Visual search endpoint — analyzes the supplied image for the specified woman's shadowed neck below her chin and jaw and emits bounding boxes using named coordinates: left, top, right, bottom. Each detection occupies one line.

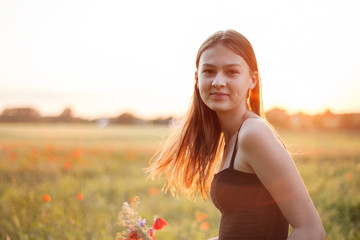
left=216, top=106, right=250, bottom=144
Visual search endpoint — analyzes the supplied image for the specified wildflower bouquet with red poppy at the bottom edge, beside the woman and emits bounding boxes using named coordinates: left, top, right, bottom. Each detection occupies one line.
left=116, top=197, right=167, bottom=240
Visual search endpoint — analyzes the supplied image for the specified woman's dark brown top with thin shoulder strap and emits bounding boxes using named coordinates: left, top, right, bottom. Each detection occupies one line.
left=210, top=121, right=289, bottom=240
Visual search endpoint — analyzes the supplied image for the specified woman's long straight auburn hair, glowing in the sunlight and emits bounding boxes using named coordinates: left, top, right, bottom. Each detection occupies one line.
left=147, top=30, right=265, bottom=198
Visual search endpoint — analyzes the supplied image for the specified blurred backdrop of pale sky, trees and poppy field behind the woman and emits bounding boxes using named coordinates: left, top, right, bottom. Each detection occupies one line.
left=0, top=0, right=360, bottom=239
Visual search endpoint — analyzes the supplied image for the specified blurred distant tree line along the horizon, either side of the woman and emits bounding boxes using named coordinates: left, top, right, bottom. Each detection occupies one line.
left=0, top=107, right=360, bottom=130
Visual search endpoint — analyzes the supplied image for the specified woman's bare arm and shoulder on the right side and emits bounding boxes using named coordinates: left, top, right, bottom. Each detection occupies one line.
left=238, top=118, right=325, bottom=240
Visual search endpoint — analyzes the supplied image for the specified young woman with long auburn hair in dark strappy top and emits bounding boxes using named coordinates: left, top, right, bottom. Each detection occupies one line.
left=150, top=30, right=325, bottom=240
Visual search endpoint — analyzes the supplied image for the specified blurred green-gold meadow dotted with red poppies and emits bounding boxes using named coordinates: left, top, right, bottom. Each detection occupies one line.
left=0, top=124, right=360, bottom=240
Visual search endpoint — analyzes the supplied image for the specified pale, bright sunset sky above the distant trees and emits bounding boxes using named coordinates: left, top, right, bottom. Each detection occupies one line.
left=0, top=0, right=360, bottom=118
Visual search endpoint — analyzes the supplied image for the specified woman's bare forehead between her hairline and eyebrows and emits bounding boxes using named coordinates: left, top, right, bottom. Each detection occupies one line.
left=199, top=44, right=248, bottom=67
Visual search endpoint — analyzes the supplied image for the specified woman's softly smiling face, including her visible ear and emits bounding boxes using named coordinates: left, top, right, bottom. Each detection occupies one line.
left=195, top=44, right=257, bottom=113
